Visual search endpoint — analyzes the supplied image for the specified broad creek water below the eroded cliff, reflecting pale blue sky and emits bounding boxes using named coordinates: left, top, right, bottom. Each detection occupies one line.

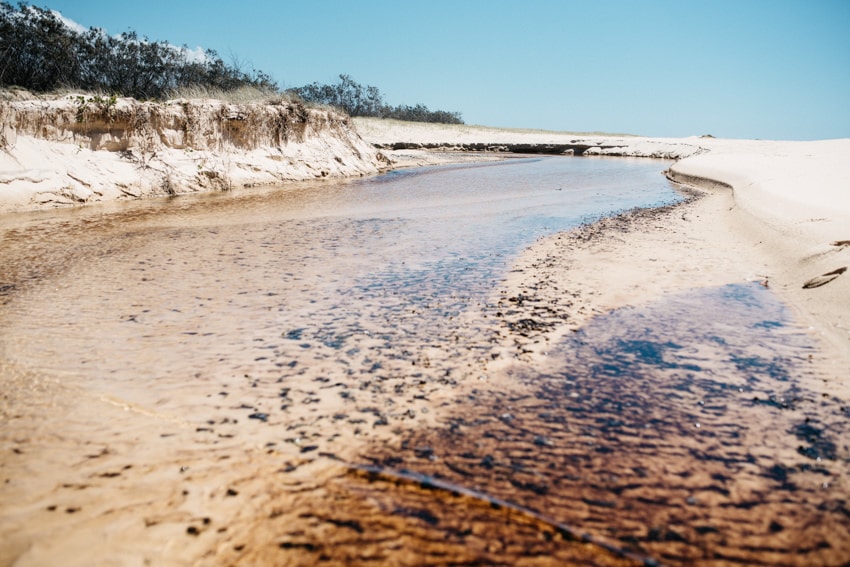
left=0, top=158, right=680, bottom=394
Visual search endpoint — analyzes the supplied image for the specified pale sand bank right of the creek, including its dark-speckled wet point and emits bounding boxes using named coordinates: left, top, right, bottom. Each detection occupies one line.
left=490, top=139, right=850, bottom=392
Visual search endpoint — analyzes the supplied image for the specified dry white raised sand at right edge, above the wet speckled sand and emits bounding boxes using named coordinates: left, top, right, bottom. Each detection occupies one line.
left=671, top=140, right=850, bottom=360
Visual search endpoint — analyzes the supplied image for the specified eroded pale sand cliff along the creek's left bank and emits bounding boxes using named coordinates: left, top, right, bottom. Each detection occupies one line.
left=0, top=94, right=387, bottom=213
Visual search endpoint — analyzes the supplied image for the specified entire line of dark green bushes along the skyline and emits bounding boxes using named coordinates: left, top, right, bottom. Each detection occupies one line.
left=0, top=0, right=463, bottom=124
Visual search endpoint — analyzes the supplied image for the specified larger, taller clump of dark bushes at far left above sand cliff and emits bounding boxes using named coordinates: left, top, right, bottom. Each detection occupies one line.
left=0, top=2, right=277, bottom=99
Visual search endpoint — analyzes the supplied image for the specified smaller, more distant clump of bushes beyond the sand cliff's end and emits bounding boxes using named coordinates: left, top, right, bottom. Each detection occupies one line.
left=288, top=75, right=463, bottom=124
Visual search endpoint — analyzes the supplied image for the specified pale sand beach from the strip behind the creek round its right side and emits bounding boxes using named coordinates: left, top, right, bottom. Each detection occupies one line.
left=355, top=119, right=850, bottom=380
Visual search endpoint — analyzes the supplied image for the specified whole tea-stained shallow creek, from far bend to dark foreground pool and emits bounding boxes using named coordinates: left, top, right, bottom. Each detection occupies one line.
left=0, top=158, right=850, bottom=565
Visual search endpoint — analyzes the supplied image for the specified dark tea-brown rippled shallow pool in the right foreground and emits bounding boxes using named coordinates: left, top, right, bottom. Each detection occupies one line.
left=340, top=284, right=850, bottom=565
